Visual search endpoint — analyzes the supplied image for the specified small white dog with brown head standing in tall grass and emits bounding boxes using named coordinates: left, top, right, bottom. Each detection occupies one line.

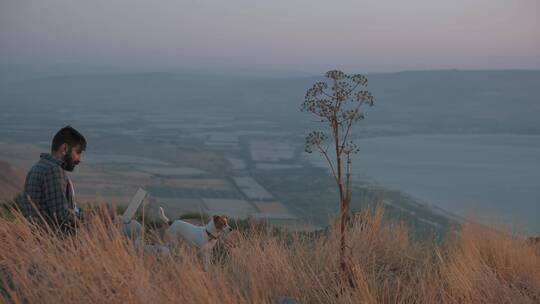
left=159, top=207, right=232, bottom=271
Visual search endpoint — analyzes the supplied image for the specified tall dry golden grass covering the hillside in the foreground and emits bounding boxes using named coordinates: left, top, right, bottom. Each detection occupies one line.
left=0, top=205, right=540, bottom=303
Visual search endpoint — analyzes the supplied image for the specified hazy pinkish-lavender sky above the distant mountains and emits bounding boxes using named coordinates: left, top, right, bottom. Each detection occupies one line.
left=0, top=0, right=540, bottom=72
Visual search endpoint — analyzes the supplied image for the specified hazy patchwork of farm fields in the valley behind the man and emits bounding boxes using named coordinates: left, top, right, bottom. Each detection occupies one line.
left=0, top=107, right=460, bottom=235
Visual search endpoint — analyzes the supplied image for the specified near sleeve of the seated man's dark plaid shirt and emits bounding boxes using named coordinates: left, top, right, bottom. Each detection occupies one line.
left=43, top=166, right=73, bottom=225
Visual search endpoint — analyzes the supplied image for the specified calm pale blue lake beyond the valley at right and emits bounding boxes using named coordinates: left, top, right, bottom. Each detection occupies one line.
left=311, top=134, right=540, bottom=234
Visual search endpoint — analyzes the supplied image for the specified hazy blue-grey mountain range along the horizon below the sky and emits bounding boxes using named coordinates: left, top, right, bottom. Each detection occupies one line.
left=0, top=70, right=540, bottom=133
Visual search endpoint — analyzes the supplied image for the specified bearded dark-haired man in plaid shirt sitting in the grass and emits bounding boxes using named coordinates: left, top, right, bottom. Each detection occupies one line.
left=17, top=126, right=86, bottom=232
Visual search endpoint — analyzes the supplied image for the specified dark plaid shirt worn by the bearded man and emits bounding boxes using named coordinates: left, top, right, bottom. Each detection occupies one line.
left=19, top=153, right=77, bottom=225
